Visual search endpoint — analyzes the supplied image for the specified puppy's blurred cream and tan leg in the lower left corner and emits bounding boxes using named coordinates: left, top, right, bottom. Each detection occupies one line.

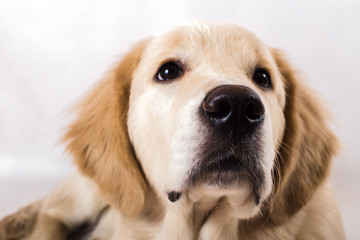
left=0, top=171, right=107, bottom=240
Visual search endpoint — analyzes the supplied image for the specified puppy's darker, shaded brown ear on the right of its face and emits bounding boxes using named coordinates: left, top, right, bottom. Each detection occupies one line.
left=271, top=49, right=339, bottom=221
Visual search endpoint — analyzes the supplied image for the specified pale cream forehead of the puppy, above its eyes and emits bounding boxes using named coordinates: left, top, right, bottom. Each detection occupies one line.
left=148, top=22, right=269, bottom=69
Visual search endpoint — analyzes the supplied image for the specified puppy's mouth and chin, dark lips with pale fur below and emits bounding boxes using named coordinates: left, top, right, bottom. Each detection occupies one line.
left=176, top=157, right=264, bottom=219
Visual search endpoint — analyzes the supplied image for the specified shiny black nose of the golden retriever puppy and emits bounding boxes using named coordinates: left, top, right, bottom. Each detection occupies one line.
left=201, top=85, right=265, bottom=138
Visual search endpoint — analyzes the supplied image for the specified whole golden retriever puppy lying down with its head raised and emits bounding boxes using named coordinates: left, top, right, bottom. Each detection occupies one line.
left=1, top=22, right=345, bottom=240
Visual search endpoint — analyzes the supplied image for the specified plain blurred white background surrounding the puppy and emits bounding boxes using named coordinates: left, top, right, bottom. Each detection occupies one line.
left=0, top=0, right=360, bottom=239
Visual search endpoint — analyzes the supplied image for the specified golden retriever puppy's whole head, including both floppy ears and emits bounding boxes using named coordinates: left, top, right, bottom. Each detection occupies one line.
left=65, top=23, right=337, bottom=219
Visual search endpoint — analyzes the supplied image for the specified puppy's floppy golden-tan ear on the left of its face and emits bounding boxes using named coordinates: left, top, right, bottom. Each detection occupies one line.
left=64, top=40, right=148, bottom=215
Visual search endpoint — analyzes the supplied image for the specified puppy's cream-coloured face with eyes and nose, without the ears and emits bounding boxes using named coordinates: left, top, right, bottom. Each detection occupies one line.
left=128, top=24, right=285, bottom=217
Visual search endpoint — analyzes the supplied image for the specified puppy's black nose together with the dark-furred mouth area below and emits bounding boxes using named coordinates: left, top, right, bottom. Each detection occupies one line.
left=168, top=85, right=265, bottom=204
